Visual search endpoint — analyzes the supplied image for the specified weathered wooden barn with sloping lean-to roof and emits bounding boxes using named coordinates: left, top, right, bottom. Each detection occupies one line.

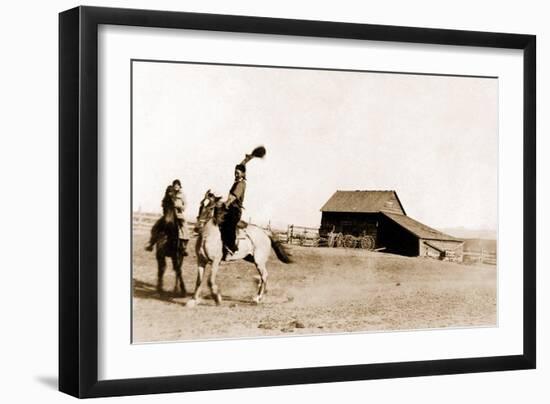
left=319, top=191, right=464, bottom=262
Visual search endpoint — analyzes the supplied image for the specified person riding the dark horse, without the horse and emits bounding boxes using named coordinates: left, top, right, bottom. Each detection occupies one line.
left=145, top=179, right=189, bottom=255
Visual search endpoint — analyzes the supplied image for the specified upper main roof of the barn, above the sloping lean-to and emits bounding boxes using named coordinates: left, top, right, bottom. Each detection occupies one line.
left=321, top=191, right=405, bottom=213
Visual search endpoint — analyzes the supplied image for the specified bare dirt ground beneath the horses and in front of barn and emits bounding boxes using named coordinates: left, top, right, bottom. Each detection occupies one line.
left=133, top=233, right=497, bottom=343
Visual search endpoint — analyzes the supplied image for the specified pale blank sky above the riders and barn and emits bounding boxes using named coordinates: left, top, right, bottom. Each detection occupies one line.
left=133, top=62, right=498, bottom=229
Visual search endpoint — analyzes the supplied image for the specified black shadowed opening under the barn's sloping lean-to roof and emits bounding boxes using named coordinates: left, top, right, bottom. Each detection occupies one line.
left=377, top=215, right=419, bottom=257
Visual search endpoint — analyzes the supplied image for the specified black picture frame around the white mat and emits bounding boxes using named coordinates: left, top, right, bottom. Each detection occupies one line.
left=59, top=7, right=536, bottom=398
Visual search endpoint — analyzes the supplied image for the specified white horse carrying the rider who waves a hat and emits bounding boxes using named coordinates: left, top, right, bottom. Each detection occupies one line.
left=187, top=190, right=292, bottom=307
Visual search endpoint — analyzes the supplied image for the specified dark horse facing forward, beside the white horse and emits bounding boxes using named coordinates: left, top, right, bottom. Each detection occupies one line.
left=155, top=200, right=187, bottom=296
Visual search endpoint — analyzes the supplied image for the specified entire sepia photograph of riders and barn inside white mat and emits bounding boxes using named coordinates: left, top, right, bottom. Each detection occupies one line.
left=131, top=60, right=499, bottom=344
